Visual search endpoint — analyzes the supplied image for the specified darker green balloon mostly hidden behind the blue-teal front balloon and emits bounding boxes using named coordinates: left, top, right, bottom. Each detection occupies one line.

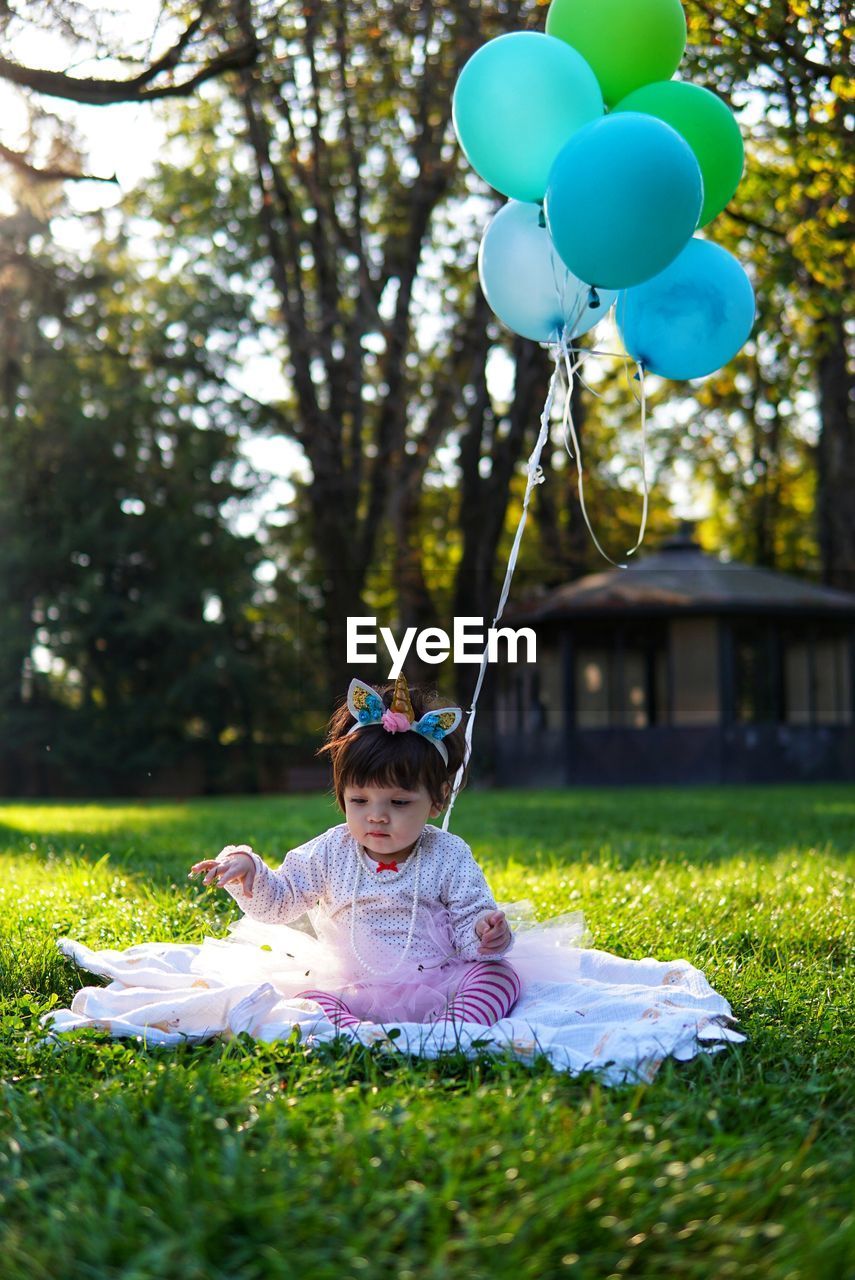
left=613, top=81, right=745, bottom=227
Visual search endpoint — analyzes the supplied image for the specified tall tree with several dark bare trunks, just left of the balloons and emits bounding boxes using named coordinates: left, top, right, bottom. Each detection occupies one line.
left=215, top=0, right=675, bottom=696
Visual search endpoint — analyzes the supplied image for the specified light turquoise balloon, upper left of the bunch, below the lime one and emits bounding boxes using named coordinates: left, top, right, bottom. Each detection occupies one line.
left=452, top=31, right=604, bottom=201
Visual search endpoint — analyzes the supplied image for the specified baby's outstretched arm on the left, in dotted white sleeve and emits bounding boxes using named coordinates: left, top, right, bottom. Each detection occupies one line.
left=208, top=835, right=326, bottom=924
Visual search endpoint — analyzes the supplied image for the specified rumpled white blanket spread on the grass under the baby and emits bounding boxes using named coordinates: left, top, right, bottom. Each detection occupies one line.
left=44, top=938, right=745, bottom=1084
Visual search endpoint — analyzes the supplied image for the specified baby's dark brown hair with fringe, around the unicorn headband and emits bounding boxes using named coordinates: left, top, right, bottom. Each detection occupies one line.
left=317, top=685, right=466, bottom=810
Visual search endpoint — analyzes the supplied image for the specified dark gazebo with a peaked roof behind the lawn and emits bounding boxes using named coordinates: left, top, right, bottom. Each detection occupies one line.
left=494, top=526, right=855, bottom=786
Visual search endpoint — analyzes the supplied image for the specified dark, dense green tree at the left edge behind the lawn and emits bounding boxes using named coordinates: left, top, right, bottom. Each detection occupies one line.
left=0, top=181, right=277, bottom=791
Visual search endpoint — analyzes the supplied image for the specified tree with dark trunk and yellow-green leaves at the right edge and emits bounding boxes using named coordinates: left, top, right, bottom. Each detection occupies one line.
left=686, top=0, right=855, bottom=590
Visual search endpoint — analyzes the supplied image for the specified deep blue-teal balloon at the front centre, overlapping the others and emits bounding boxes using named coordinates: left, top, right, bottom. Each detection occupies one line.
left=545, top=111, right=704, bottom=289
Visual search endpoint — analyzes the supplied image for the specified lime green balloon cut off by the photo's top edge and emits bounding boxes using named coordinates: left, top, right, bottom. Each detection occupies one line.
left=547, top=0, right=686, bottom=106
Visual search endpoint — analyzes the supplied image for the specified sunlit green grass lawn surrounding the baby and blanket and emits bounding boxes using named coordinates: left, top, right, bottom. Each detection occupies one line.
left=0, top=786, right=855, bottom=1280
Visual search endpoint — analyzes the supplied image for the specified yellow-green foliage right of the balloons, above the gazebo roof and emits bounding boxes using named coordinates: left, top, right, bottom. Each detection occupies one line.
left=672, top=0, right=855, bottom=570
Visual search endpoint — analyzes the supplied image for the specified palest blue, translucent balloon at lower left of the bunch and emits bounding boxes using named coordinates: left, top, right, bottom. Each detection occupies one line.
left=477, top=200, right=617, bottom=342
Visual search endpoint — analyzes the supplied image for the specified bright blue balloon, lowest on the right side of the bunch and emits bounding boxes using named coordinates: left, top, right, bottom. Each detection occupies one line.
left=616, top=239, right=754, bottom=379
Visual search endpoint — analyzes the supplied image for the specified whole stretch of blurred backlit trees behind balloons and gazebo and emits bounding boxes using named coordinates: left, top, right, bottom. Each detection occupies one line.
left=0, top=0, right=855, bottom=791
